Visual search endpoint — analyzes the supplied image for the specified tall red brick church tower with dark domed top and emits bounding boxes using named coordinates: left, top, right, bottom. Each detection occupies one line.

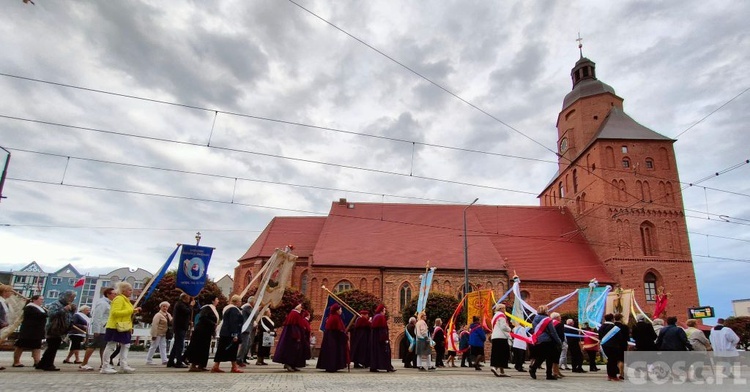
left=539, top=46, right=700, bottom=320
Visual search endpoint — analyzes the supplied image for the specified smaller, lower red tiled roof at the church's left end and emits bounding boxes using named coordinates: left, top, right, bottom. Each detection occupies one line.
left=239, top=217, right=326, bottom=261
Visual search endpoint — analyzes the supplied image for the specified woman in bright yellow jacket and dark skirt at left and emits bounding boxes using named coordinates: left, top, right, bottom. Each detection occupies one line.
left=100, top=281, right=141, bottom=374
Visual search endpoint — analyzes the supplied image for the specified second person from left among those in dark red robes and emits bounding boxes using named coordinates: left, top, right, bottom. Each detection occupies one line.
left=315, top=303, right=349, bottom=373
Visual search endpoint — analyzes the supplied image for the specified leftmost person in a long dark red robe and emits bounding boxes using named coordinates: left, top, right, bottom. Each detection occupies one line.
left=273, top=304, right=310, bottom=372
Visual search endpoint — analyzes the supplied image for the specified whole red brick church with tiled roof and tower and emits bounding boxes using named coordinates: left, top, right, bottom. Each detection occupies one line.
left=234, top=52, right=699, bottom=352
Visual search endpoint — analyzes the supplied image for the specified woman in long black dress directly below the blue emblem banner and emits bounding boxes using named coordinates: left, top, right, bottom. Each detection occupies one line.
left=187, top=294, right=219, bottom=372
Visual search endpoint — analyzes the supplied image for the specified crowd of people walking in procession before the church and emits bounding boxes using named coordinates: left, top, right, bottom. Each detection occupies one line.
left=0, top=282, right=739, bottom=381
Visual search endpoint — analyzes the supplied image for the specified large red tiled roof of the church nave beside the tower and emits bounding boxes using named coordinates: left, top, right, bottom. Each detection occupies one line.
left=308, top=202, right=612, bottom=282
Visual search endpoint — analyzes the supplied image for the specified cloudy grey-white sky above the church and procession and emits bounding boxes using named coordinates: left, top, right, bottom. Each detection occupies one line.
left=0, top=0, right=750, bottom=315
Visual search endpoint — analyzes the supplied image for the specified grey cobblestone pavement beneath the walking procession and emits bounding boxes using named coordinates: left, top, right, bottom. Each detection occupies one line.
left=0, top=351, right=624, bottom=392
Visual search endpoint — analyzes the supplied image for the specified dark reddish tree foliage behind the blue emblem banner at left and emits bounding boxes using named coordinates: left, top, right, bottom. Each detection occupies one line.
left=140, top=271, right=227, bottom=324
